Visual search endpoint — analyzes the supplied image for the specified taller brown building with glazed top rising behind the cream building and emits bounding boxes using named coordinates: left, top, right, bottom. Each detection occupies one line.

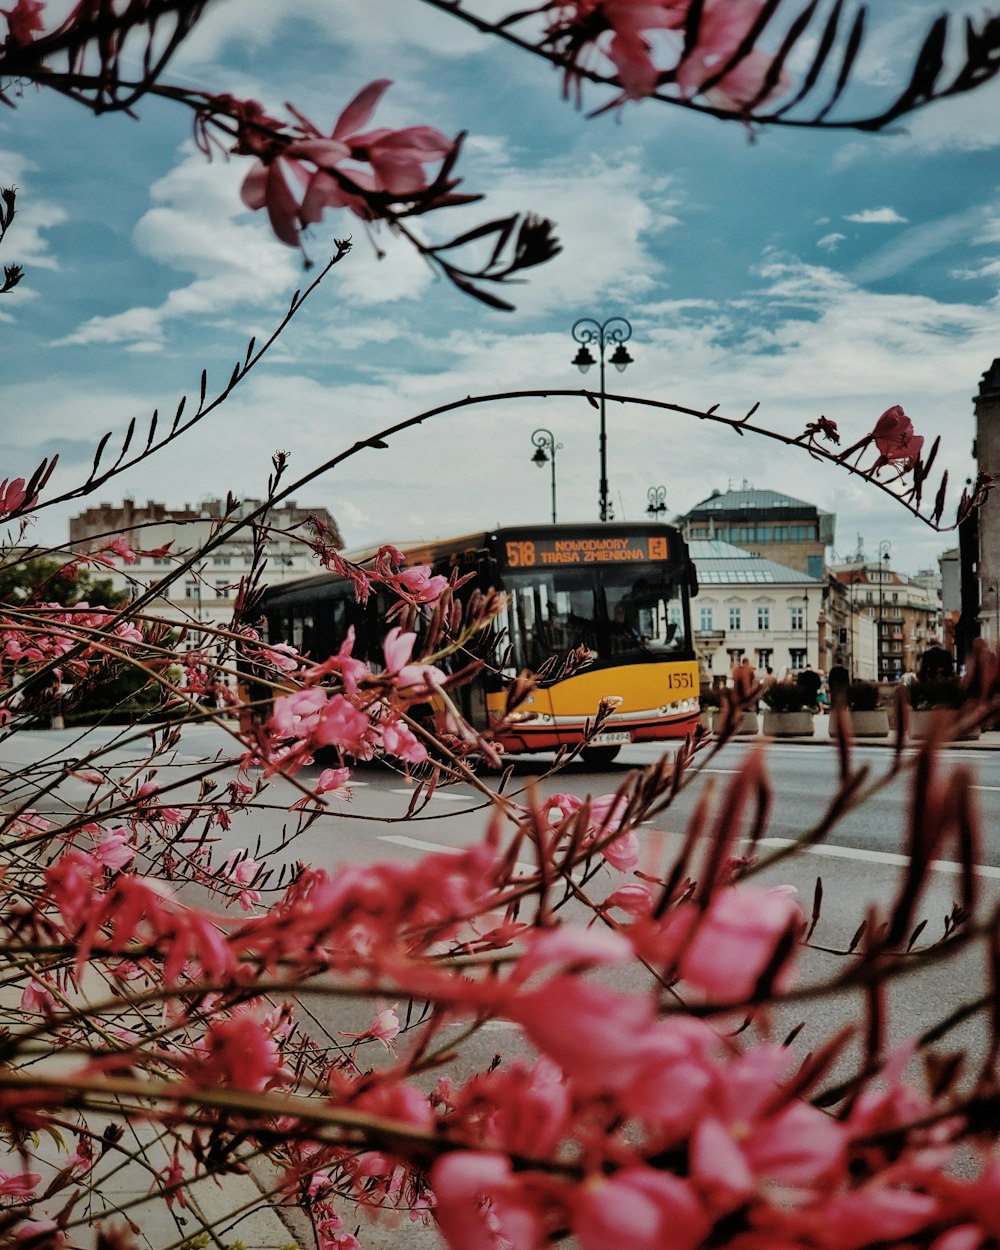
left=675, top=483, right=836, bottom=579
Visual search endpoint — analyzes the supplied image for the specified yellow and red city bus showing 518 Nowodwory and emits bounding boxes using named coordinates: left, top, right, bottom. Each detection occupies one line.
left=263, top=523, right=700, bottom=766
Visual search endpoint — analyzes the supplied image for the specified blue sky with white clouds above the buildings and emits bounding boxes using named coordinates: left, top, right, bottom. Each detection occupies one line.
left=0, top=0, right=1000, bottom=573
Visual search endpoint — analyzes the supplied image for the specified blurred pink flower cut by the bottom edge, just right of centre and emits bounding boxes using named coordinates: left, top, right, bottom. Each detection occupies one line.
left=571, top=1168, right=713, bottom=1250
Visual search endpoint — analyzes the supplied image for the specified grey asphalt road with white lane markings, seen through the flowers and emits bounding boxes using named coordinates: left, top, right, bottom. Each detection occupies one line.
left=0, top=726, right=1000, bottom=1246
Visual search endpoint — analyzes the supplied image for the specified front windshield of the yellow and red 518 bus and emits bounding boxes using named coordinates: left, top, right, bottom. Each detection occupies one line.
left=503, top=565, right=689, bottom=669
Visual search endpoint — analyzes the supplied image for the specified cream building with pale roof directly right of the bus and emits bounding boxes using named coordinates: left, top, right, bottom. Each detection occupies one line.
left=689, top=539, right=826, bottom=680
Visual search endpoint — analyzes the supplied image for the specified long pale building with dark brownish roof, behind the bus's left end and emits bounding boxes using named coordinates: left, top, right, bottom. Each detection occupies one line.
left=70, top=499, right=344, bottom=625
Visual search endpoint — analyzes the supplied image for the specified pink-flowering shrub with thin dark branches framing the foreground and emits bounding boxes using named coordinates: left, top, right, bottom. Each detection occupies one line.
left=0, top=0, right=1000, bottom=1250
